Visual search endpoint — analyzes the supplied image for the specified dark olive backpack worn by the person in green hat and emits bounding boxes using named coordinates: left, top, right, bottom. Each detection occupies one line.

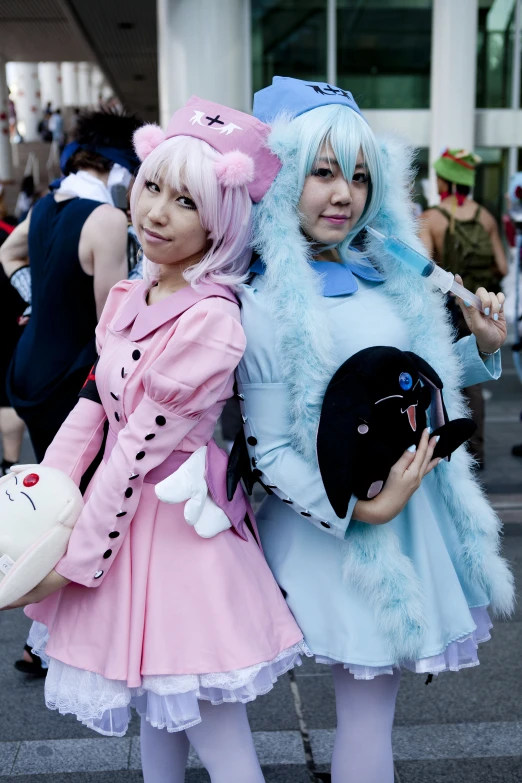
left=433, top=206, right=501, bottom=292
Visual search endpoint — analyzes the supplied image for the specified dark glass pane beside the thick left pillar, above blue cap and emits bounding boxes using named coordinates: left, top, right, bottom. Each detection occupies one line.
left=252, top=0, right=327, bottom=91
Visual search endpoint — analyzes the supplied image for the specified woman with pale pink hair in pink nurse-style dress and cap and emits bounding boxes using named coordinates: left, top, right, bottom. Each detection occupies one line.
left=9, top=97, right=306, bottom=783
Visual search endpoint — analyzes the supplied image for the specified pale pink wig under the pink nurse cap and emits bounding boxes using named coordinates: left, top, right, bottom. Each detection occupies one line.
left=130, top=136, right=252, bottom=286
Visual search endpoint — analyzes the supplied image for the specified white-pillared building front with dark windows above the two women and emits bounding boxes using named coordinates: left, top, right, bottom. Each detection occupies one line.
left=158, top=0, right=522, bottom=214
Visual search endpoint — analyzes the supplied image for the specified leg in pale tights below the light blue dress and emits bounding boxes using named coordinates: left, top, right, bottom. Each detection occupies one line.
left=332, top=666, right=400, bottom=783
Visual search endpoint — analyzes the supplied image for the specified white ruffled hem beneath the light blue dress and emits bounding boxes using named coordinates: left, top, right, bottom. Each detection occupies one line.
left=315, top=606, right=493, bottom=680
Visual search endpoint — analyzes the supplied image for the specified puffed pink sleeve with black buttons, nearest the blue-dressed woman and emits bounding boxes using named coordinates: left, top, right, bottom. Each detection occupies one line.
left=56, top=299, right=245, bottom=587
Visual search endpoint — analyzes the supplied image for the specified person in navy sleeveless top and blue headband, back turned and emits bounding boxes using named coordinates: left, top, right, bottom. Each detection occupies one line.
left=0, top=112, right=141, bottom=461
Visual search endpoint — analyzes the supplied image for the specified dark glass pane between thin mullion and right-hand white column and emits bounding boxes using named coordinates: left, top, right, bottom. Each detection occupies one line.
left=337, top=0, right=432, bottom=109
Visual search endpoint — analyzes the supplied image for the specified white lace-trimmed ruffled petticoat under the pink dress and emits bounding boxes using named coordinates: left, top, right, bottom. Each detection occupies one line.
left=28, top=623, right=311, bottom=737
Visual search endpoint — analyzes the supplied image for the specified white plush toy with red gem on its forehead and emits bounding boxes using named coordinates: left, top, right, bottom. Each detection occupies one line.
left=0, top=465, right=83, bottom=609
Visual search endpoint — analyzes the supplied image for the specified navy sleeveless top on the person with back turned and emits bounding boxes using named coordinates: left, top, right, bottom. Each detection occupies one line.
left=8, top=194, right=100, bottom=461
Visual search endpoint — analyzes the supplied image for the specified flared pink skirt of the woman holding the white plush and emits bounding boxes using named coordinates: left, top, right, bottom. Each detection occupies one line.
left=26, top=482, right=306, bottom=733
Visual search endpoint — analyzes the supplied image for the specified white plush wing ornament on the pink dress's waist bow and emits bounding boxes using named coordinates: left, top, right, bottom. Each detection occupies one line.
left=155, top=446, right=232, bottom=538
